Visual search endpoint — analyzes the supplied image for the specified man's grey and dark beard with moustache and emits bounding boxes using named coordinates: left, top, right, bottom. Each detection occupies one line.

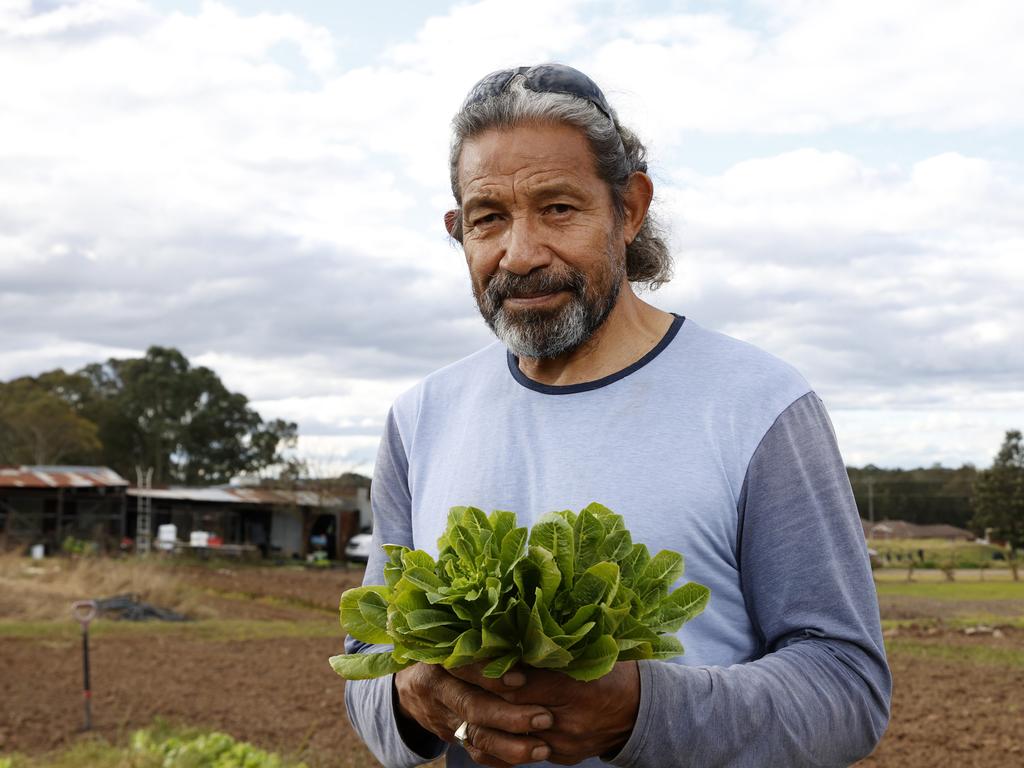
left=474, top=254, right=626, bottom=359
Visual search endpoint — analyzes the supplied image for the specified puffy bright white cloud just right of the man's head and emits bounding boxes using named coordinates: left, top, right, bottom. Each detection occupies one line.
left=667, top=148, right=1024, bottom=243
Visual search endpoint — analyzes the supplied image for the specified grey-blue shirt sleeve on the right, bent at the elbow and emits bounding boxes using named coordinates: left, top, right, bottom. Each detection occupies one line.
left=611, top=392, right=892, bottom=768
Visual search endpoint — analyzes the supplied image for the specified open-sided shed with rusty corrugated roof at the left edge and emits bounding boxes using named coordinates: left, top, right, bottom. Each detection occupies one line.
left=0, top=466, right=128, bottom=552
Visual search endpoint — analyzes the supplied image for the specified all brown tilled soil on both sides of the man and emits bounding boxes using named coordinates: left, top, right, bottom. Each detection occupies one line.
left=0, top=567, right=1024, bottom=768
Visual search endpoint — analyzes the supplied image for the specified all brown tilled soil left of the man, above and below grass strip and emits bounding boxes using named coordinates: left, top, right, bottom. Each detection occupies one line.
left=0, top=567, right=368, bottom=768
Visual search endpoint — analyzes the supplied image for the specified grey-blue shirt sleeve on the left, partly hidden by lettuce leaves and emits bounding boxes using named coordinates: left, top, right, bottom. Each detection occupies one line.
left=345, top=412, right=447, bottom=768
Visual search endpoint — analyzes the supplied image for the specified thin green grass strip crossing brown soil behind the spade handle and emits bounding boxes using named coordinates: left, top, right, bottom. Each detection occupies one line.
left=0, top=616, right=344, bottom=643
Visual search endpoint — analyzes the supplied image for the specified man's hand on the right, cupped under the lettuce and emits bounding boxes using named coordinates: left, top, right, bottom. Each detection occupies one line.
left=452, top=662, right=640, bottom=765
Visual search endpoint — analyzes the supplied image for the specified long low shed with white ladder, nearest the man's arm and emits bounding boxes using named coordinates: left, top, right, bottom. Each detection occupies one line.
left=128, top=485, right=370, bottom=559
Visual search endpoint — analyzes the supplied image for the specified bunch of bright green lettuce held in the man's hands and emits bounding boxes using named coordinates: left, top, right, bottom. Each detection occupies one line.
left=330, top=503, right=711, bottom=680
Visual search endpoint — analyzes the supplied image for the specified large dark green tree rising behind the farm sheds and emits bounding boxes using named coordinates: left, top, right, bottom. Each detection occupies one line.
left=39, top=346, right=297, bottom=485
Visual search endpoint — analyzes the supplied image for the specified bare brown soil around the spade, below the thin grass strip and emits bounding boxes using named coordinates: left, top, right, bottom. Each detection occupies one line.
left=0, top=635, right=373, bottom=768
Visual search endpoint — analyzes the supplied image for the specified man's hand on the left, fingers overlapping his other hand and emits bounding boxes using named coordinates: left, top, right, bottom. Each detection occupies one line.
left=394, top=664, right=553, bottom=768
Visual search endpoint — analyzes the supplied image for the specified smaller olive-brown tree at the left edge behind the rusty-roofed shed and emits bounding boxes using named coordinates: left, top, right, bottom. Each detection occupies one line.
left=0, top=377, right=102, bottom=465
